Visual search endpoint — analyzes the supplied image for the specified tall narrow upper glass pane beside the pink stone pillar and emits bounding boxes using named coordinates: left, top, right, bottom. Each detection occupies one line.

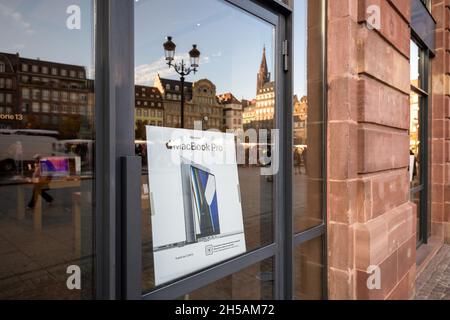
left=293, top=0, right=324, bottom=233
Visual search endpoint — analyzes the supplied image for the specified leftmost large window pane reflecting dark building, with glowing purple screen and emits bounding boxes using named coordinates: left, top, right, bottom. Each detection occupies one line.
left=0, top=0, right=94, bottom=299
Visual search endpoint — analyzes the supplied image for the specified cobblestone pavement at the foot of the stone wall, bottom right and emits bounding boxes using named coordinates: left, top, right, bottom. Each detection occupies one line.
left=416, top=246, right=450, bottom=300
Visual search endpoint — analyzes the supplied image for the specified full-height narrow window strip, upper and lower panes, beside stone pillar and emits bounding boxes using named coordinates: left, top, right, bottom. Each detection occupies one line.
left=285, top=0, right=326, bottom=300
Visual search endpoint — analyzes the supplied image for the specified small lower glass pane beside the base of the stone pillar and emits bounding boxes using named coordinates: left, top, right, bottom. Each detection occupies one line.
left=294, top=237, right=325, bottom=300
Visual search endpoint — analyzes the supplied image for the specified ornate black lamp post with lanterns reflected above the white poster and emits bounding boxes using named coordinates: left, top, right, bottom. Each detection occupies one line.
left=164, top=37, right=200, bottom=128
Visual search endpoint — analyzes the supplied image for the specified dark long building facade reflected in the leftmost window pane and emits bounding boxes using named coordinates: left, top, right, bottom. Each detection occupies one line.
left=0, top=53, right=94, bottom=139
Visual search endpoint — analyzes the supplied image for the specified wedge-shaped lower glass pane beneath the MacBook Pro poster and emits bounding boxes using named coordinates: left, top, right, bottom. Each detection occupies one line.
left=179, top=259, right=274, bottom=300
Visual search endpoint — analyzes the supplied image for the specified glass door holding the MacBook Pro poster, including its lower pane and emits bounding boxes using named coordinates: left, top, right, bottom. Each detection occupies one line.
left=134, top=0, right=290, bottom=300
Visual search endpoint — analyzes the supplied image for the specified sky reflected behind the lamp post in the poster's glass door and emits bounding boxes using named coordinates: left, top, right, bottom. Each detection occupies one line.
left=135, top=0, right=274, bottom=99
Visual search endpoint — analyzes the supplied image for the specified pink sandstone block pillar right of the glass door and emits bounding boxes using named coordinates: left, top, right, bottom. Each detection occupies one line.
left=328, top=0, right=417, bottom=299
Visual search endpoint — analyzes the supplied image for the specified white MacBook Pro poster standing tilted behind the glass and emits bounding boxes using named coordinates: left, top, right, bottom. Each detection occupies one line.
left=146, top=126, right=246, bottom=286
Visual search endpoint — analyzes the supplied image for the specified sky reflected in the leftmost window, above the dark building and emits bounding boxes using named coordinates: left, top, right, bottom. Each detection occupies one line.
left=0, top=0, right=93, bottom=76
